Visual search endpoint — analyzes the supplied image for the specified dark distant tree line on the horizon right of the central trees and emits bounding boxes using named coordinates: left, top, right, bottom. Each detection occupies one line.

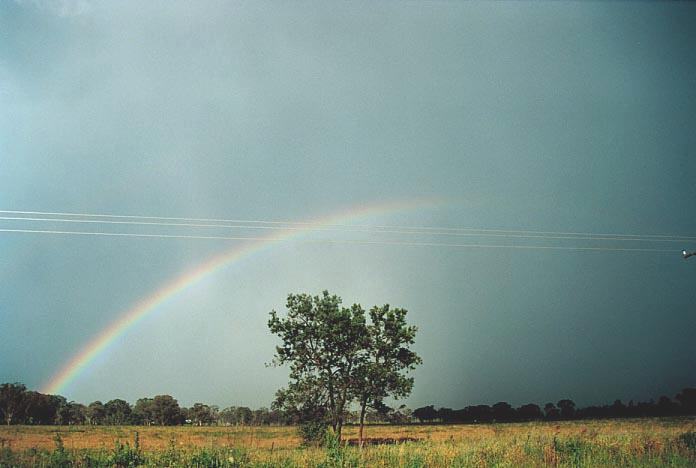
left=413, top=388, right=696, bottom=423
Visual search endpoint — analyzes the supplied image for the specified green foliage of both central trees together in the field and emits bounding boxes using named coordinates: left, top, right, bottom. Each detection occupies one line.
left=268, top=291, right=421, bottom=440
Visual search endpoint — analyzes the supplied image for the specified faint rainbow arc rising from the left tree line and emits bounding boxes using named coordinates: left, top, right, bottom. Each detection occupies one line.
left=41, top=199, right=437, bottom=394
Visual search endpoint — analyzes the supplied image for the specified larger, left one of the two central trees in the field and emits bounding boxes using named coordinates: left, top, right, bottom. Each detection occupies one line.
left=268, top=291, right=369, bottom=440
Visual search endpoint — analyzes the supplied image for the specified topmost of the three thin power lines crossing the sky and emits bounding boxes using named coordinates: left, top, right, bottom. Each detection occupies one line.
left=0, top=210, right=696, bottom=241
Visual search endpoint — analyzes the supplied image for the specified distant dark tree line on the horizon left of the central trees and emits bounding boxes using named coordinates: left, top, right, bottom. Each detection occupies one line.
left=0, top=383, right=288, bottom=426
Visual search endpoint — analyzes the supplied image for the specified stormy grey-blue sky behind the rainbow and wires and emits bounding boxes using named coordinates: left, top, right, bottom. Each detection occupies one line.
left=0, top=0, right=696, bottom=408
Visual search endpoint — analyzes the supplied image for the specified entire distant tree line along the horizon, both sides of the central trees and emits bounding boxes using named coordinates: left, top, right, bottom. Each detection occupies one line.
left=0, top=383, right=696, bottom=426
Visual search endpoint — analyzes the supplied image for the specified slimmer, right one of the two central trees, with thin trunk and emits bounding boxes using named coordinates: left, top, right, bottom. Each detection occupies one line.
left=354, top=304, right=422, bottom=446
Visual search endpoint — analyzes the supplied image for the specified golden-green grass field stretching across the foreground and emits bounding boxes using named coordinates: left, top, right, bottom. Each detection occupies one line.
left=0, top=418, right=696, bottom=467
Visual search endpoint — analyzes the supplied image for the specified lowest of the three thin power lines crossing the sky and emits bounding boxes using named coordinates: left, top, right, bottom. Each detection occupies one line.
left=0, top=229, right=675, bottom=253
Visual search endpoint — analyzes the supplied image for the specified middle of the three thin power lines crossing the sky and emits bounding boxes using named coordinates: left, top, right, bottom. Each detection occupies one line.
left=0, top=216, right=690, bottom=242
